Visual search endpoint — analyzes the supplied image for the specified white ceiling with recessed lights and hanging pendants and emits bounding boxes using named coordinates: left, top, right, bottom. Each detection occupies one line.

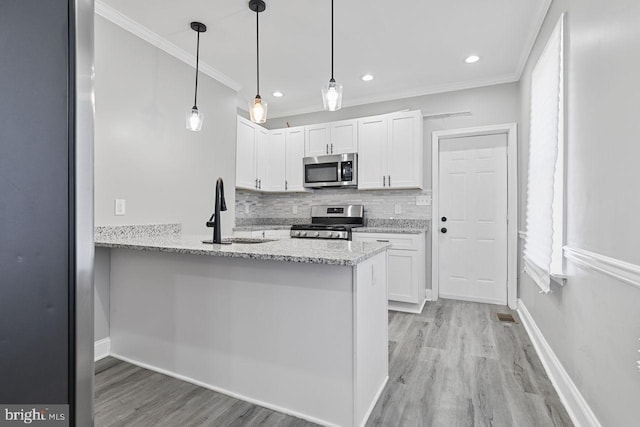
left=97, top=0, right=551, bottom=117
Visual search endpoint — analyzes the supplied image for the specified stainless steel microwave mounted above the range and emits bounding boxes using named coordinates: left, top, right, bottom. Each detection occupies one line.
left=302, top=153, right=358, bottom=188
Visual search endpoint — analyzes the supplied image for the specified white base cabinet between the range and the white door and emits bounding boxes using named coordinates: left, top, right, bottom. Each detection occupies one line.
left=353, top=232, right=427, bottom=313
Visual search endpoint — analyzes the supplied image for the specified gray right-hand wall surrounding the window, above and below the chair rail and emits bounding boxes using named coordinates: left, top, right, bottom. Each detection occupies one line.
left=519, top=0, right=640, bottom=427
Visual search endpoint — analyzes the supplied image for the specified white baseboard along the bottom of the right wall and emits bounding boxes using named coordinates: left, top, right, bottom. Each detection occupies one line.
left=518, top=299, right=601, bottom=427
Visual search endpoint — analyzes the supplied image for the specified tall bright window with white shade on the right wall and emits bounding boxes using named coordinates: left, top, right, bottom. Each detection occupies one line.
left=524, top=14, right=564, bottom=293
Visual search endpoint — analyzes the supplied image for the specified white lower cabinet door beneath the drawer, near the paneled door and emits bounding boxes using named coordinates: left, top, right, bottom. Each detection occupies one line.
left=387, top=249, right=424, bottom=303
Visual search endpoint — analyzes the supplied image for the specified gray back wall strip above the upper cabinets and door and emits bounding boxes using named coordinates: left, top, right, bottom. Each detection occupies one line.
left=266, top=83, right=520, bottom=189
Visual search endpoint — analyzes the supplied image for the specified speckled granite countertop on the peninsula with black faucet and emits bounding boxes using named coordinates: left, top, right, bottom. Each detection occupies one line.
left=95, top=234, right=390, bottom=266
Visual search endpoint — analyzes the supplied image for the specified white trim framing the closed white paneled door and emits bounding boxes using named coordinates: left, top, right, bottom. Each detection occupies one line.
left=431, top=123, right=518, bottom=310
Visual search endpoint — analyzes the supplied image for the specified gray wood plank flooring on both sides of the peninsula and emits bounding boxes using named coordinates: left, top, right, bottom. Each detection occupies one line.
left=95, top=300, right=572, bottom=427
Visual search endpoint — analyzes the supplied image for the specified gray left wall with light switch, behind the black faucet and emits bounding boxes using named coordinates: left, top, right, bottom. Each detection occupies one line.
left=95, top=16, right=236, bottom=234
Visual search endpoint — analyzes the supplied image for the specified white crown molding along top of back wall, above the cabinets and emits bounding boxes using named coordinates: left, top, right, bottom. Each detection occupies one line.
left=264, top=73, right=519, bottom=118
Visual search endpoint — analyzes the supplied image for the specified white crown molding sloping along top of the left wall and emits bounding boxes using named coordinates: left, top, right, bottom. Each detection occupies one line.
left=95, top=0, right=242, bottom=92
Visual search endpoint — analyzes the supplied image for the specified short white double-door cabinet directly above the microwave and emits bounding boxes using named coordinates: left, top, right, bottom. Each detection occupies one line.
left=305, top=120, right=358, bottom=157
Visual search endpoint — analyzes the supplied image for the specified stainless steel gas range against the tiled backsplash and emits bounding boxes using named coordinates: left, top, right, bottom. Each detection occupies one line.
left=291, top=205, right=364, bottom=240
